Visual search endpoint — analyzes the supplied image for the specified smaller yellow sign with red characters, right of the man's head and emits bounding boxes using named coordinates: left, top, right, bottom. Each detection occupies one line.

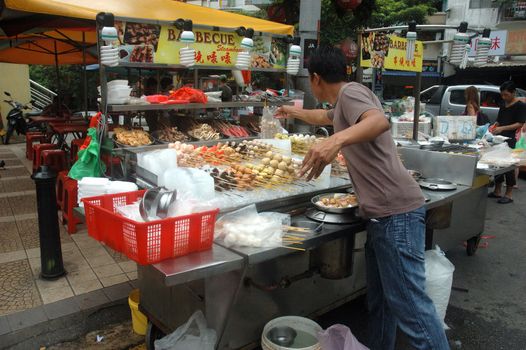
left=360, top=33, right=424, bottom=72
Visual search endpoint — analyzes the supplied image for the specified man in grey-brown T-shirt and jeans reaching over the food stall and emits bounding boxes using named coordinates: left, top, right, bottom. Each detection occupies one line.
left=278, top=47, right=449, bottom=350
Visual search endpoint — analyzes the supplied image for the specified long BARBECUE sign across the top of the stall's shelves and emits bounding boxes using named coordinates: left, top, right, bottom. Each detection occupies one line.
left=116, top=22, right=287, bottom=69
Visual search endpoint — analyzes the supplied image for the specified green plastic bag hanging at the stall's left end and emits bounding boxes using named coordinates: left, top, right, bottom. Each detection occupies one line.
left=68, top=128, right=106, bottom=180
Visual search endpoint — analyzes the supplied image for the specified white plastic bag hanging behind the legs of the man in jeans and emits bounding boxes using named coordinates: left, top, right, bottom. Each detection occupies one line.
left=425, top=246, right=455, bottom=329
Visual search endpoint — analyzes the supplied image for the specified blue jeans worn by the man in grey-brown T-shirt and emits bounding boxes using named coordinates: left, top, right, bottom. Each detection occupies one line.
left=365, top=207, right=449, bottom=350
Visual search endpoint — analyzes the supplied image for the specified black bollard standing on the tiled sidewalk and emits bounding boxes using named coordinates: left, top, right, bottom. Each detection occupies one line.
left=31, top=166, right=66, bottom=279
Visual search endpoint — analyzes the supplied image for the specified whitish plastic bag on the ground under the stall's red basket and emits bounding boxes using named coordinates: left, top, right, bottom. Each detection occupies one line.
left=154, top=310, right=217, bottom=350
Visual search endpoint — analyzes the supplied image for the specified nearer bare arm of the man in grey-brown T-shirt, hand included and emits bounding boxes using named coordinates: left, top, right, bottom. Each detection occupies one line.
left=300, top=109, right=389, bottom=181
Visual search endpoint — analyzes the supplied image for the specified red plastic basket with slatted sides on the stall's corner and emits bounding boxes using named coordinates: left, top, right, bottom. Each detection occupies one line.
left=82, top=191, right=219, bottom=265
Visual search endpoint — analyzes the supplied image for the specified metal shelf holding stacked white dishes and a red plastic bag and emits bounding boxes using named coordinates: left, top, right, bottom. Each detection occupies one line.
left=108, top=101, right=293, bottom=112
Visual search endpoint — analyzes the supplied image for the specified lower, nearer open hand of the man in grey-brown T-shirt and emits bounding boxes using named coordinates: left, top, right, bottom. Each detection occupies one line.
left=300, top=137, right=342, bottom=181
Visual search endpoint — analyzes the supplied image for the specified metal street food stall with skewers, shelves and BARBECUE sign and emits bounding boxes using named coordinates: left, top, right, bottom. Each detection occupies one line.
left=65, top=6, right=524, bottom=349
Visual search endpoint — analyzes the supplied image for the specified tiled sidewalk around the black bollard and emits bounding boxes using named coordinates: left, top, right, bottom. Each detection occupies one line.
left=0, top=144, right=137, bottom=348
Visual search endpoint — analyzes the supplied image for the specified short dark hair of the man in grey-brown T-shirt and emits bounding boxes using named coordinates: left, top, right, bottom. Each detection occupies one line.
left=309, top=46, right=347, bottom=84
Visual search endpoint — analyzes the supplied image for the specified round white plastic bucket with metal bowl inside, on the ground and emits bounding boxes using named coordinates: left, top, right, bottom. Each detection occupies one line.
left=261, top=316, right=323, bottom=350
